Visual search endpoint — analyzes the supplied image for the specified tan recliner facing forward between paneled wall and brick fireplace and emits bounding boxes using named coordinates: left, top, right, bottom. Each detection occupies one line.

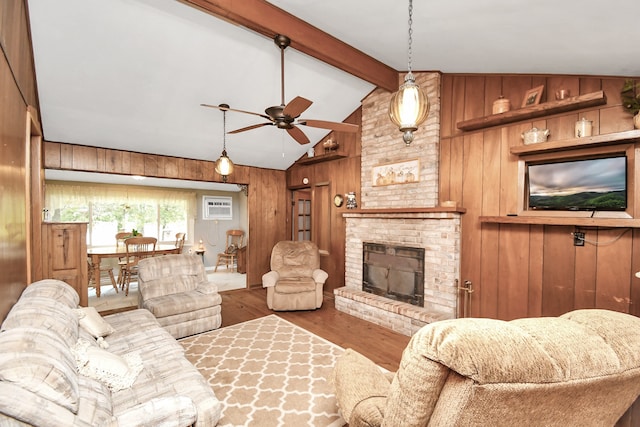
left=262, top=240, right=328, bottom=311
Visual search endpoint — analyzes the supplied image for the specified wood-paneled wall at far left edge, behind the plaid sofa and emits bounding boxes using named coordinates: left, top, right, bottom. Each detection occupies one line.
left=0, top=0, right=38, bottom=320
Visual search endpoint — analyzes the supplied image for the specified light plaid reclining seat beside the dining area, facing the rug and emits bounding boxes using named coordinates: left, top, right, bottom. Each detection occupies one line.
left=138, top=254, right=222, bottom=339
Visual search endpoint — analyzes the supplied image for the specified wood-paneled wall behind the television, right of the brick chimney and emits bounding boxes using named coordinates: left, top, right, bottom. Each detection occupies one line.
left=439, top=75, right=640, bottom=320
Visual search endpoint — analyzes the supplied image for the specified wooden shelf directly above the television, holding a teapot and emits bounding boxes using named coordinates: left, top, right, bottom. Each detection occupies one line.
left=510, top=130, right=640, bottom=156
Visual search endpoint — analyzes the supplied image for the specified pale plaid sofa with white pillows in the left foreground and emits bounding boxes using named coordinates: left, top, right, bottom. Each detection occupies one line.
left=0, top=279, right=222, bottom=427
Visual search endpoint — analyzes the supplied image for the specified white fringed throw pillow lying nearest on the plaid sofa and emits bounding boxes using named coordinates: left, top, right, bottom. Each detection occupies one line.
left=71, top=339, right=143, bottom=391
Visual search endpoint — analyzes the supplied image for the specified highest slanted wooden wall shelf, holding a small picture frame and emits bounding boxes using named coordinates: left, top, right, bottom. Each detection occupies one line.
left=456, top=91, right=607, bottom=131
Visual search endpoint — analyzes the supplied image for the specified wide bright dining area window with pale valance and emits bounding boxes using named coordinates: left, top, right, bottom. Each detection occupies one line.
left=45, top=183, right=196, bottom=246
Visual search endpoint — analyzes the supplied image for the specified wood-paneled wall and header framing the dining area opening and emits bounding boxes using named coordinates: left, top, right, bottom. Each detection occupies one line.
left=43, top=142, right=287, bottom=286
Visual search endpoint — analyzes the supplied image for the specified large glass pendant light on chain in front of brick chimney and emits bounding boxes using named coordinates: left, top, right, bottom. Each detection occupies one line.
left=389, top=0, right=429, bottom=145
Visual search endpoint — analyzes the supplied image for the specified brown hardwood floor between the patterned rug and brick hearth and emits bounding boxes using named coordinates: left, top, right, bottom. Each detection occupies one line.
left=220, top=287, right=410, bottom=371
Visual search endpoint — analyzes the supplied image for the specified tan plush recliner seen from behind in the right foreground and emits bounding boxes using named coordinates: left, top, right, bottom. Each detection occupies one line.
left=334, top=310, right=640, bottom=427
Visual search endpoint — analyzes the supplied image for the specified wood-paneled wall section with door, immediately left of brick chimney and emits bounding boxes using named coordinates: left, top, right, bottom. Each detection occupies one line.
left=287, top=108, right=362, bottom=295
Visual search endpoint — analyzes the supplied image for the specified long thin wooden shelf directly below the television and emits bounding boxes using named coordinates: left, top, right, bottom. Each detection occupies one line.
left=479, top=216, right=640, bottom=228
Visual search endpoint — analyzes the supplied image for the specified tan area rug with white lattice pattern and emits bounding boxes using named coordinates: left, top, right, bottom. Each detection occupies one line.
left=180, top=314, right=346, bottom=427
